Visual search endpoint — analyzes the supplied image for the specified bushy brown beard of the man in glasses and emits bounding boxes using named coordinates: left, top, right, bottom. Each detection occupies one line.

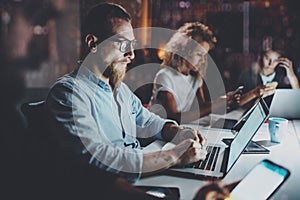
left=103, top=65, right=126, bottom=89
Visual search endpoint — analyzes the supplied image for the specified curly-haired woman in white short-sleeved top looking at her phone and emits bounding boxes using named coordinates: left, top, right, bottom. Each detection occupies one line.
left=149, top=22, right=238, bottom=123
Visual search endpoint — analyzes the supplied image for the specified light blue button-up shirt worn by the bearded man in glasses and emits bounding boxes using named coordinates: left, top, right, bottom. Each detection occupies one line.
left=46, top=67, right=173, bottom=181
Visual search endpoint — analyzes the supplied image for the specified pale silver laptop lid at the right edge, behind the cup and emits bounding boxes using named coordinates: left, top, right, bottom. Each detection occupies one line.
left=270, top=89, right=300, bottom=119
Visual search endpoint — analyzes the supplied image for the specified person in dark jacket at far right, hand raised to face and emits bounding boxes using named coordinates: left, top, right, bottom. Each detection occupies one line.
left=238, top=49, right=300, bottom=106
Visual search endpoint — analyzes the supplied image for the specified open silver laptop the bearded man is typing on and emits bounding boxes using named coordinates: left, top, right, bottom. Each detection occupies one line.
left=167, top=99, right=269, bottom=180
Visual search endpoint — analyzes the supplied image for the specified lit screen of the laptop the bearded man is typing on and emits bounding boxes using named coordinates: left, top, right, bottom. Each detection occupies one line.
left=227, top=99, right=269, bottom=171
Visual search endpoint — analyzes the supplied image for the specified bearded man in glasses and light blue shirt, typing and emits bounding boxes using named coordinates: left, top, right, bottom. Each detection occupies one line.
left=46, top=3, right=207, bottom=185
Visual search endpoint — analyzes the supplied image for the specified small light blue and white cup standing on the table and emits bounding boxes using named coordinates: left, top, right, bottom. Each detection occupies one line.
left=269, top=117, right=289, bottom=143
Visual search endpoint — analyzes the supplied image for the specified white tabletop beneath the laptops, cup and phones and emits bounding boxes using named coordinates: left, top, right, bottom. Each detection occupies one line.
left=136, top=121, right=300, bottom=200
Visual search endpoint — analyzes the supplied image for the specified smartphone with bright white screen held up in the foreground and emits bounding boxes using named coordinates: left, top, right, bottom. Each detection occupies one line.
left=228, top=159, right=290, bottom=200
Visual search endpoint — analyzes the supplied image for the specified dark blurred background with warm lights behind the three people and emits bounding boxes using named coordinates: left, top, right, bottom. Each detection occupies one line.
left=0, top=0, right=300, bottom=102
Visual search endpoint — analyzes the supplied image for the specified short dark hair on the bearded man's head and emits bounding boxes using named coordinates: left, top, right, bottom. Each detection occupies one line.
left=81, top=3, right=131, bottom=42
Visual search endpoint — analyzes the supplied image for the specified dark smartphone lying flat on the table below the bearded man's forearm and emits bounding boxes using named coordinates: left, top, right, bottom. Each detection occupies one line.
left=136, top=186, right=180, bottom=200
